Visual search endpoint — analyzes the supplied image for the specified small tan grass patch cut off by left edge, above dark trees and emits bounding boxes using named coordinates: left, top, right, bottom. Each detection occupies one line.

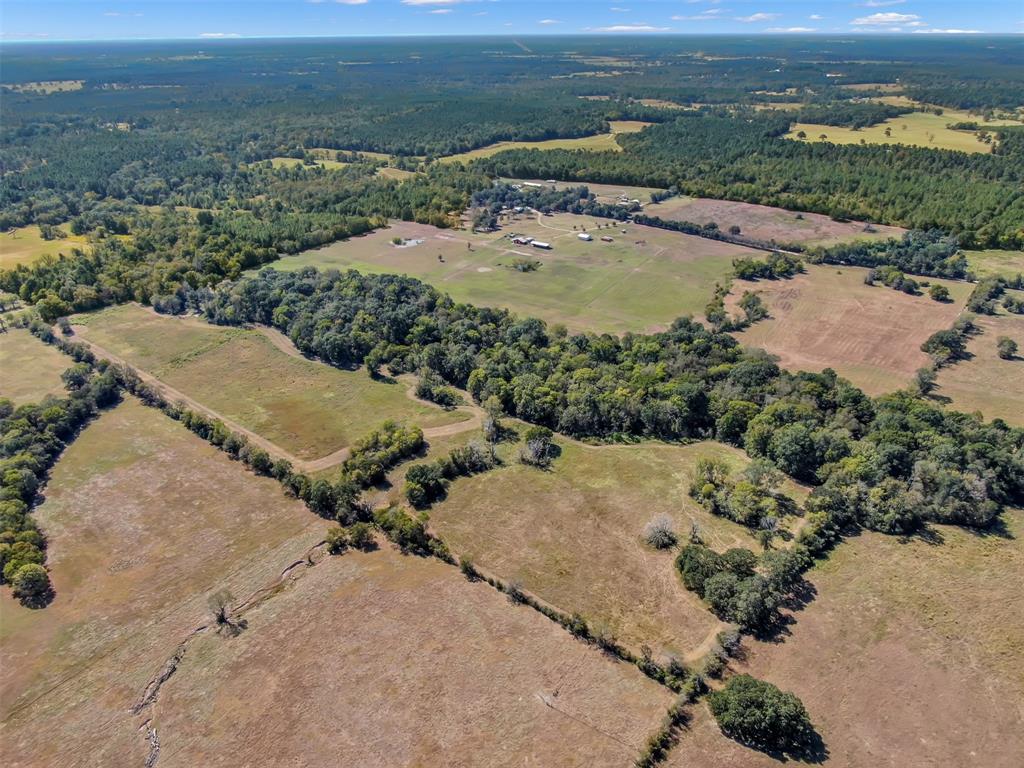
left=0, top=328, right=75, bottom=406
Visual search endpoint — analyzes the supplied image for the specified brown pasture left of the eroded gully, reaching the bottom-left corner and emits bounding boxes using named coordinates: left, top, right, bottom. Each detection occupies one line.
left=0, top=398, right=327, bottom=766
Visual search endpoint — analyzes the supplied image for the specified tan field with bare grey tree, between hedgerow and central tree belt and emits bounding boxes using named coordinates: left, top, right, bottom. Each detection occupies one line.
left=430, top=438, right=793, bottom=655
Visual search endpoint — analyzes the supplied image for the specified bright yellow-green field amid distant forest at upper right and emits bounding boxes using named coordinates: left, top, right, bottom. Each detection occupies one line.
left=785, top=110, right=995, bottom=154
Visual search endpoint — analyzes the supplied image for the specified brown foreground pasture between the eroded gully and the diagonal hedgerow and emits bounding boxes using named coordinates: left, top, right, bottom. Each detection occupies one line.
left=146, top=545, right=672, bottom=767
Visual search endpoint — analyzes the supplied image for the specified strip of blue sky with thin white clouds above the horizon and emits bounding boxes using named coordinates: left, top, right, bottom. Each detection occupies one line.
left=0, top=0, right=1024, bottom=40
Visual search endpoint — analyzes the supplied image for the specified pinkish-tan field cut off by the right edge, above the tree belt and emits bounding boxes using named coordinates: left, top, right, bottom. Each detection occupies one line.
left=935, top=307, right=1024, bottom=426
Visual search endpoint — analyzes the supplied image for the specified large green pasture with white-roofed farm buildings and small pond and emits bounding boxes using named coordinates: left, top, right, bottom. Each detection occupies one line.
left=271, top=214, right=757, bottom=332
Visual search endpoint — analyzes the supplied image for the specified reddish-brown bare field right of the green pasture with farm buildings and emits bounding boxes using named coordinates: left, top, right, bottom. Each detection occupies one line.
left=726, top=265, right=972, bottom=395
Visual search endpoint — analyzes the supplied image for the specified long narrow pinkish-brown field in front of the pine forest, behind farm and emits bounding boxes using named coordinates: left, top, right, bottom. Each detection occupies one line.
left=644, top=197, right=904, bottom=245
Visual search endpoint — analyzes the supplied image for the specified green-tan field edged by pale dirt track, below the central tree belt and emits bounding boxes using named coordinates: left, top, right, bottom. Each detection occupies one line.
left=73, top=304, right=467, bottom=459
